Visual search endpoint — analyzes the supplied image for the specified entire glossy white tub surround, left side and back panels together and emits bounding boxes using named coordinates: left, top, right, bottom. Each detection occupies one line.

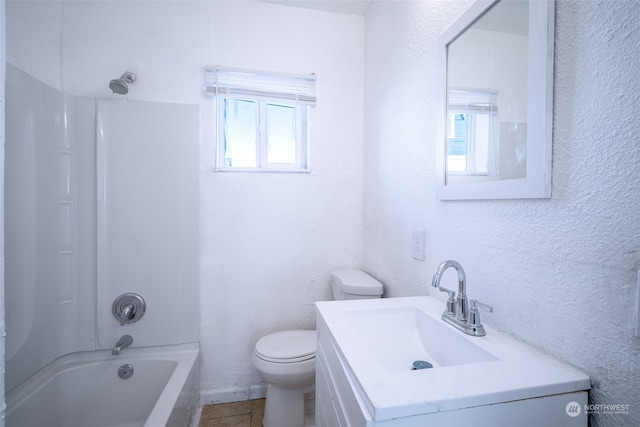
left=5, top=65, right=199, bottom=390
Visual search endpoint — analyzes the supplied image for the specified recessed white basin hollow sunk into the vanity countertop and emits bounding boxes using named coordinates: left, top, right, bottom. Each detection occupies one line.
left=344, top=307, right=498, bottom=372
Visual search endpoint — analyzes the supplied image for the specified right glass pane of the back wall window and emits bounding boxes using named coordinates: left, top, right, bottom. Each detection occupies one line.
left=266, top=104, right=296, bottom=164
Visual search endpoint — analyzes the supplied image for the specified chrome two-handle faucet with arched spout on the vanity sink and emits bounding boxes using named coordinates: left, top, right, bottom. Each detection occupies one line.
left=431, top=260, right=493, bottom=337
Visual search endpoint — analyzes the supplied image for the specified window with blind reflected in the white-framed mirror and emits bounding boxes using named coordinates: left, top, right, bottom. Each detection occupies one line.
left=447, top=89, right=498, bottom=176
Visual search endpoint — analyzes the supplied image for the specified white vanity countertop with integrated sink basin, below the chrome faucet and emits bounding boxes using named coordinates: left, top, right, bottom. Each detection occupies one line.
left=316, top=296, right=590, bottom=421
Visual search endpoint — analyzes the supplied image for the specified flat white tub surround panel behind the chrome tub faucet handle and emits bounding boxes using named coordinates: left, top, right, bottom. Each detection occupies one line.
left=96, top=99, right=199, bottom=348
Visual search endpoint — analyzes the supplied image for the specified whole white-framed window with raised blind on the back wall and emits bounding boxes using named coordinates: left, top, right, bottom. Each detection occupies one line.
left=207, top=67, right=315, bottom=172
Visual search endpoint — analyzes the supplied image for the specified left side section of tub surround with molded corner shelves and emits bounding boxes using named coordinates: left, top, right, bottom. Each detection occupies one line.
left=4, top=64, right=96, bottom=391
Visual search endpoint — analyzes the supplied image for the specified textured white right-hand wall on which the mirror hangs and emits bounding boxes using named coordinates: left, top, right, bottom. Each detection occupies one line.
left=363, top=0, right=640, bottom=427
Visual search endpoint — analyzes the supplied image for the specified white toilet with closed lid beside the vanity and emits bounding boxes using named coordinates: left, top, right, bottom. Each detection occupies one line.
left=253, top=269, right=383, bottom=427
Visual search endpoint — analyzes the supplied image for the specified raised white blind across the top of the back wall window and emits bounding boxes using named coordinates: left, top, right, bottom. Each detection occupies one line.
left=205, top=66, right=316, bottom=105
